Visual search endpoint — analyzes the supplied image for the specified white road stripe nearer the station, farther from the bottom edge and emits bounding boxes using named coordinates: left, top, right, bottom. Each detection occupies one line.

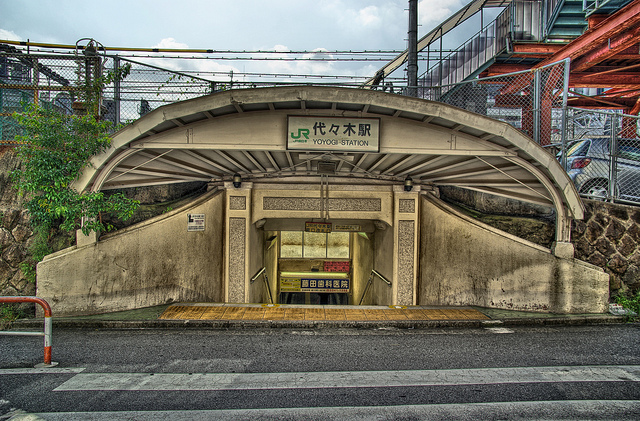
left=54, top=366, right=640, bottom=391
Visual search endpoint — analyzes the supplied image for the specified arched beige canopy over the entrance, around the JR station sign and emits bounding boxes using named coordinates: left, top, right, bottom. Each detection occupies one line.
left=74, top=86, right=583, bottom=242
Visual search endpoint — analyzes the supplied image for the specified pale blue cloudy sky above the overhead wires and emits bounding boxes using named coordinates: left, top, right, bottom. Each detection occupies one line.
left=0, top=0, right=496, bottom=82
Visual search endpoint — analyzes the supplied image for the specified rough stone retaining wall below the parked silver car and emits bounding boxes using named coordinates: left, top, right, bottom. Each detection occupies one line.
left=571, top=200, right=640, bottom=296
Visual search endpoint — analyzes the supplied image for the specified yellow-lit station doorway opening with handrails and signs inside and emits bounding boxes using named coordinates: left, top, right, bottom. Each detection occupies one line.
left=264, top=220, right=375, bottom=305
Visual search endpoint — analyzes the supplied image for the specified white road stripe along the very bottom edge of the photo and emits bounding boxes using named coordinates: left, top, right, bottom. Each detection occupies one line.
left=18, top=400, right=640, bottom=421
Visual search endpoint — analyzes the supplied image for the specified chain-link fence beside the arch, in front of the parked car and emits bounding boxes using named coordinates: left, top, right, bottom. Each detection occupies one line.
left=419, top=61, right=640, bottom=204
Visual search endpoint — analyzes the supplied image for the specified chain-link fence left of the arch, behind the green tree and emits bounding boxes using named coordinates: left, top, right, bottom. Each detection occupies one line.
left=0, top=49, right=218, bottom=135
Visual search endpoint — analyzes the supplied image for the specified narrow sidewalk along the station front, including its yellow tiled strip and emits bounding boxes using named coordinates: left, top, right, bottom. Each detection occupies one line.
left=6, top=303, right=626, bottom=329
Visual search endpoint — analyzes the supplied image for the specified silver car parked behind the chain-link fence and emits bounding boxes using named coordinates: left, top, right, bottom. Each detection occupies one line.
left=558, top=138, right=640, bottom=202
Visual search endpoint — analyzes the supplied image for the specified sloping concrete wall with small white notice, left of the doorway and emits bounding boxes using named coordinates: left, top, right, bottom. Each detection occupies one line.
left=38, top=191, right=225, bottom=316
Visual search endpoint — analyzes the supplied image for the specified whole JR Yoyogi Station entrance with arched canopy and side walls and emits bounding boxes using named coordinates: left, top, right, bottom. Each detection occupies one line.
left=38, top=87, right=609, bottom=315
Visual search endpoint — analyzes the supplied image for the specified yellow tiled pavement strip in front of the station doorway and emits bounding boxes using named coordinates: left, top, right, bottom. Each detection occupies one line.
left=159, top=304, right=489, bottom=321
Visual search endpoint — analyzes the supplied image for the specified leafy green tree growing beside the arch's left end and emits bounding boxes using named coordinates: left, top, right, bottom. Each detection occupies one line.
left=12, top=106, right=139, bottom=234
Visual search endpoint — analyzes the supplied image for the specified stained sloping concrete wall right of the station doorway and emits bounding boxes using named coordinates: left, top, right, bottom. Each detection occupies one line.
left=418, top=195, right=609, bottom=313
